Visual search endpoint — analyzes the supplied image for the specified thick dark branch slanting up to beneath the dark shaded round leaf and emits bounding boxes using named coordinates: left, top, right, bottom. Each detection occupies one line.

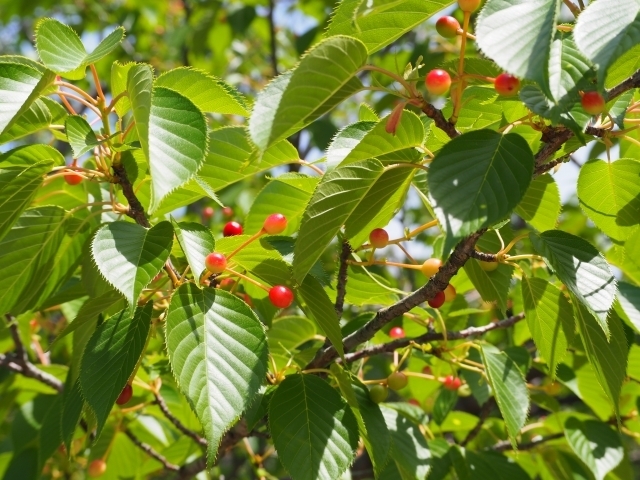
left=306, top=229, right=485, bottom=368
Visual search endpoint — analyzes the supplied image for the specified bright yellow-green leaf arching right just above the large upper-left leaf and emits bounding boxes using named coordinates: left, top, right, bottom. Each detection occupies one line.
left=155, top=67, right=249, bottom=117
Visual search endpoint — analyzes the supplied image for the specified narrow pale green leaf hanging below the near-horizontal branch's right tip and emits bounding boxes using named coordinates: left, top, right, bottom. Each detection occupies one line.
left=482, top=345, right=529, bottom=449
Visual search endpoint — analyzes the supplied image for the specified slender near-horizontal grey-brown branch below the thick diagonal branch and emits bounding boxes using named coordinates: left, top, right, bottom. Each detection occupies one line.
left=345, top=313, right=524, bottom=362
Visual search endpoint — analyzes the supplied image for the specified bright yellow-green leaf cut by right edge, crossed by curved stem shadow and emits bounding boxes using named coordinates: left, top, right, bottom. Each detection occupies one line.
left=578, top=159, right=640, bottom=243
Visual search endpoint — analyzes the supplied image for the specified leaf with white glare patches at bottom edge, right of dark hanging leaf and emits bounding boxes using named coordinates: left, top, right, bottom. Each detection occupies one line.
left=381, top=407, right=431, bottom=480
